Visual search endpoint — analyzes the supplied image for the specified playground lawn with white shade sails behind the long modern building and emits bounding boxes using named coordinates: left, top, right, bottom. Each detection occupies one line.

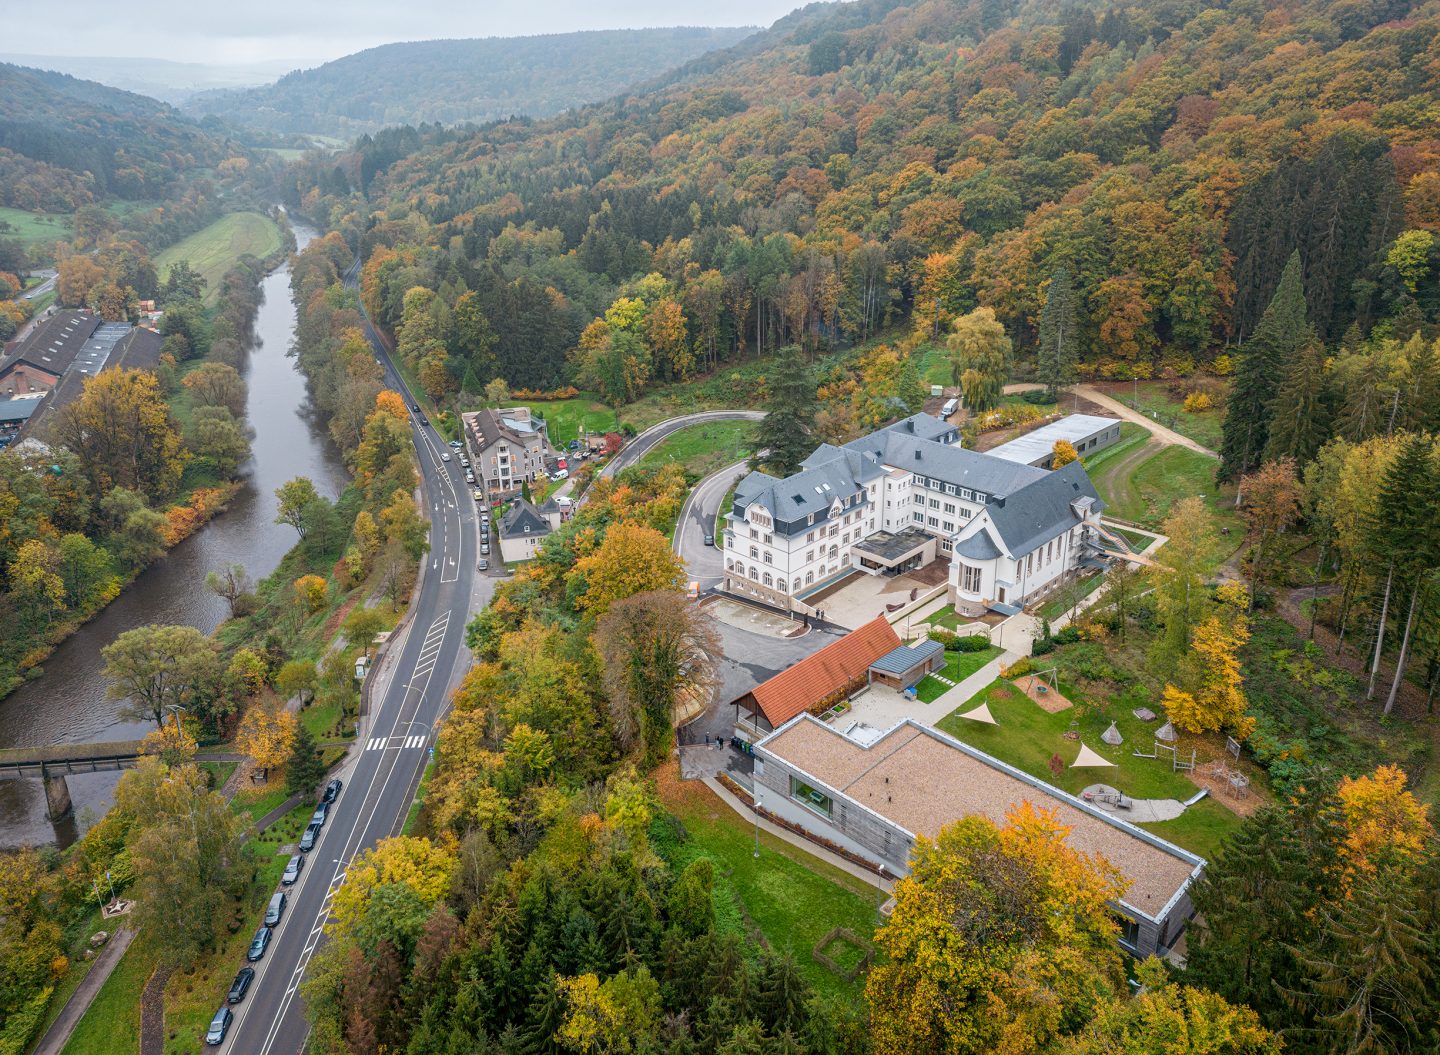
left=936, top=679, right=1240, bottom=856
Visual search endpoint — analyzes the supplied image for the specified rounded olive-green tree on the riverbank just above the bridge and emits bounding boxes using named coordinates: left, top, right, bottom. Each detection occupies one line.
left=101, top=625, right=220, bottom=725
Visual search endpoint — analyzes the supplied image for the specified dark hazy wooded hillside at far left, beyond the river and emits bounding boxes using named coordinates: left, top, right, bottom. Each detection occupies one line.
left=0, top=63, right=235, bottom=213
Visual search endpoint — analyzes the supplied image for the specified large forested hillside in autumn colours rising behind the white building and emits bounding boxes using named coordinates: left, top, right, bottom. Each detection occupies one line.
left=291, top=0, right=1440, bottom=400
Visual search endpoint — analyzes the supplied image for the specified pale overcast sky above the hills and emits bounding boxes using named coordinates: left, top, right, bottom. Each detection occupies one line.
left=0, top=0, right=804, bottom=66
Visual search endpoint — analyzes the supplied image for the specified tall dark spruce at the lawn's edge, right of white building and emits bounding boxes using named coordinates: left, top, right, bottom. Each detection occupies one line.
left=1220, top=250, right=1315, bottom=479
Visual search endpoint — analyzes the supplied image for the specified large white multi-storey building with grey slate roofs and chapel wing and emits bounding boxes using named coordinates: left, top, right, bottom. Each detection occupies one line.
left=723, top=415, right=1103, bottom=615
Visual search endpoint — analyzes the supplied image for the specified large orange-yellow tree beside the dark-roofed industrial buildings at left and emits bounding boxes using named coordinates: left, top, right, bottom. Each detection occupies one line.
left=52, top=368, right=186, bottom=501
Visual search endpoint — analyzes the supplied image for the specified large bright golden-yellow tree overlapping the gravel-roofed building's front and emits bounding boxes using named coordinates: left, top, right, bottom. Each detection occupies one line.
left=865, top=803, right=1125, bottom=1055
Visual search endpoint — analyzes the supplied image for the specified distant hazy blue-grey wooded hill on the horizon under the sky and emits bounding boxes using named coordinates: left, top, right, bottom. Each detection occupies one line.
left=187, top=27, right=755, bottom=135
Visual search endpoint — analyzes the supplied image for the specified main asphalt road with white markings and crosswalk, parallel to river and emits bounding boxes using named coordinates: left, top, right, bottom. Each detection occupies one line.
left=215, top=261, right=495, bottom=1055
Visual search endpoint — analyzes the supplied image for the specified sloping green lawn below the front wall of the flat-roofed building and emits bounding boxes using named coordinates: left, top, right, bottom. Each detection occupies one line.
left=654, top=764, right=878, bottom=1000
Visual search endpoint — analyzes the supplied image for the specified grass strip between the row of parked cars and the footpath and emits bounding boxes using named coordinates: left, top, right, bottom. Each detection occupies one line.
left=166, top=803, right=314, bottom=1055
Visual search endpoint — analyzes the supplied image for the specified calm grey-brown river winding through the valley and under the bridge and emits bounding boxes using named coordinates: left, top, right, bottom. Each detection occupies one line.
left=0, top=225, right=347, bottom=846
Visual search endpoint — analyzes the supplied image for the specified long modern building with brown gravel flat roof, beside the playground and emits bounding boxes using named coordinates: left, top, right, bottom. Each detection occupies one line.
left=755, top=714, right=1205, bottom=957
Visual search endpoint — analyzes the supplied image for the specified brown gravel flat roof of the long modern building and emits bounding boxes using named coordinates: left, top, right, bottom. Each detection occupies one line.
left=756, top=714, right=1204, bottom=918
